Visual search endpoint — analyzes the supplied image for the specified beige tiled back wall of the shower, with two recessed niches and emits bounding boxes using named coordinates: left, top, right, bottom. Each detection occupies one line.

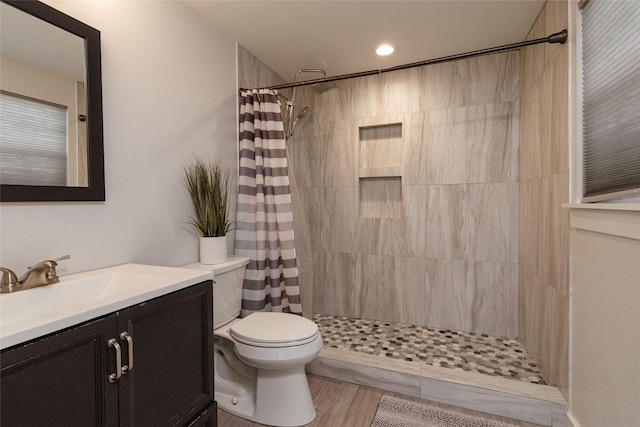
left=288, top=52, right=520, bottom=337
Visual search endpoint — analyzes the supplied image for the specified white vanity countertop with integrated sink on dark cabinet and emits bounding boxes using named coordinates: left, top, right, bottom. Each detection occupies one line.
left=0, top=264, right=213, bottom=349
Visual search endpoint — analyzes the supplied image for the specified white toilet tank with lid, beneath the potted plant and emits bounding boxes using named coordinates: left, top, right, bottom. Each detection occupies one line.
left=185, top=256, right=249, bottom=329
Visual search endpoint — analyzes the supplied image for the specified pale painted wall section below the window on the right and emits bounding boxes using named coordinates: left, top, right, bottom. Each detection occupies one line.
left=570, top=204, right=640, bottom=427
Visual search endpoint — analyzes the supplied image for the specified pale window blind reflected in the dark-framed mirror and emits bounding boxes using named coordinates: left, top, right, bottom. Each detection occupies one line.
left=0, top=92, right=68, bottom=186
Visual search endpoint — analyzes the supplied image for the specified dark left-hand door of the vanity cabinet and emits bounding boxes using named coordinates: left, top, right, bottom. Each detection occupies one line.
left=0, top=316, right=118, bottom=427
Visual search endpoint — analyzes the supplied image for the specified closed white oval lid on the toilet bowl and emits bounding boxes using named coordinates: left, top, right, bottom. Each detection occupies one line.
left=229, top=312, right=318, bottom=346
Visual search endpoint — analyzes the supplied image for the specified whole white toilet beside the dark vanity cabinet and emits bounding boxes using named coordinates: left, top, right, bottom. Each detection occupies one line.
left=186, top=256, right=322, bottom=426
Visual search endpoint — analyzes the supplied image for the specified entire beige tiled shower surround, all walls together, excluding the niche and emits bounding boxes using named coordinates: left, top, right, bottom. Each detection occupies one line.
left=238, top=1, right=569, bottom=397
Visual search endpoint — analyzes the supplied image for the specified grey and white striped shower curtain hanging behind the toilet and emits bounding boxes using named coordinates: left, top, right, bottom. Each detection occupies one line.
left=236, top=89, right=302, bottom=317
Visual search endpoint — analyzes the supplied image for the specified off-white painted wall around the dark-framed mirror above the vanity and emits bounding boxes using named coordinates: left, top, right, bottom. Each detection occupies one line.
left=0, top=0, right=237, bottom=275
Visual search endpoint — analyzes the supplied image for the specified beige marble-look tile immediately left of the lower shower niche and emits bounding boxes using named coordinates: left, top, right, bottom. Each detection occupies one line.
left=322, top=187, right=358, bottom=253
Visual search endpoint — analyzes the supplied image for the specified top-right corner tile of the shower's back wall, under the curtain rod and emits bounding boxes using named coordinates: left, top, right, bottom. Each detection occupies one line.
left=465, top=51, right=520, bottom=105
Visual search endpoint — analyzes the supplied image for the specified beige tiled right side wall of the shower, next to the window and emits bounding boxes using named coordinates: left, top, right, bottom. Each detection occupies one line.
left=519, top=1, right=569, bottom=398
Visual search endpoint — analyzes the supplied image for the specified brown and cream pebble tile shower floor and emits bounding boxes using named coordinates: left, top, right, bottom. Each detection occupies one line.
left=313, top=314, right=546, bottom=385
